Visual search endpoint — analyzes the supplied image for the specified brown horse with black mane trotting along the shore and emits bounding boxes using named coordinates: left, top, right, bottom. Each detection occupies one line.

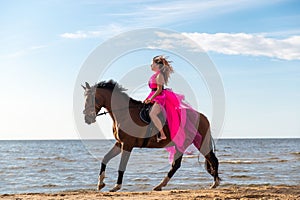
left=82, top=80, right=221, bottom=192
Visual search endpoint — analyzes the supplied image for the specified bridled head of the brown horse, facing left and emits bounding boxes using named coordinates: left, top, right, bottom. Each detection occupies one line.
left=81, top=82, right=102, bottom=124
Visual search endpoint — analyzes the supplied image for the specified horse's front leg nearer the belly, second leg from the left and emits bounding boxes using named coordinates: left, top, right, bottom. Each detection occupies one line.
left=110, top=144, right=133, bottom=192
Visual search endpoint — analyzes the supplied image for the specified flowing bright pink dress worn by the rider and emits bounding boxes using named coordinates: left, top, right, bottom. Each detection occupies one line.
left=147, top=71, right=202, bottom=159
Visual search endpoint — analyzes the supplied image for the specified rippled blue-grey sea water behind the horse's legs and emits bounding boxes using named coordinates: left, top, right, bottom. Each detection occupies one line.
left=0, top=139, right=300, bottom=194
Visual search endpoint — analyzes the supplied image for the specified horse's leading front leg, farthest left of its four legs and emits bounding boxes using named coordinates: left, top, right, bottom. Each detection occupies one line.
left=98, top=142, right=121, bottom=190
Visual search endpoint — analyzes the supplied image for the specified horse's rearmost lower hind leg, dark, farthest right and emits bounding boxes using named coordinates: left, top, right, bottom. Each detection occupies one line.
left=205, top=151, right=221, bottom=188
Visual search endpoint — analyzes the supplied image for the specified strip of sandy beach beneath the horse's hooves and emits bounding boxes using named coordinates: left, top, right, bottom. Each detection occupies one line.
left=0, top=185, right=300, bottom=200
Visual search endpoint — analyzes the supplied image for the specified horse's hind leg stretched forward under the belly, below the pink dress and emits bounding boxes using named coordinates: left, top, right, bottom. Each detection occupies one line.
left=153, top=149, right=182, bottom=191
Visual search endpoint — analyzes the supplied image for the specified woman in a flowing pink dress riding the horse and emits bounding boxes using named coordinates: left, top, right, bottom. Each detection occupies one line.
left=144, top=56, right=202, bottom=155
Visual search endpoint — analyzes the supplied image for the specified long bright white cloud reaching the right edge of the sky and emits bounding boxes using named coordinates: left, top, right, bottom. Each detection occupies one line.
left=183, top=33, right=300, bottom=60
